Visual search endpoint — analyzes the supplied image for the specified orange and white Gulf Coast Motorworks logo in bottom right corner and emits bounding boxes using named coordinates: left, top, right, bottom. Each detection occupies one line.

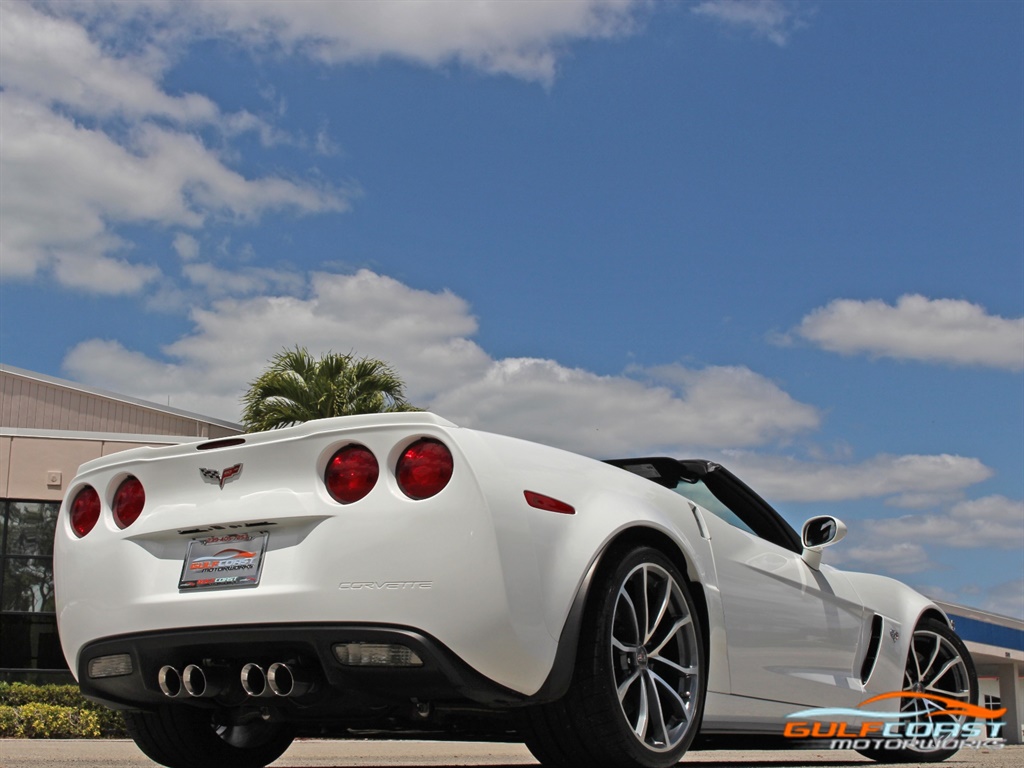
left=782, top=691, right=1007, bottom=751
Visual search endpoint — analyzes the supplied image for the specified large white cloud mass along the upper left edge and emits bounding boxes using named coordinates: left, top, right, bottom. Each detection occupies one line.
left=0, top=2, right=347, bottom=294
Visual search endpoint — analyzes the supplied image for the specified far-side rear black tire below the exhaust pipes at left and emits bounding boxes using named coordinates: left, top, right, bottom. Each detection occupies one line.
left=124, top=705, right=295, bottom=768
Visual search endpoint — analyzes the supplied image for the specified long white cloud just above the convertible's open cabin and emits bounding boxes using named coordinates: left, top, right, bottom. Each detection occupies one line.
left=433, top=358, right=819, bottom=457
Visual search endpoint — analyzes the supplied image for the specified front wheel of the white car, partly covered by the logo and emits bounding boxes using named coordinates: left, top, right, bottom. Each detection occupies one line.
left=857, top=618, right=978, bottom=763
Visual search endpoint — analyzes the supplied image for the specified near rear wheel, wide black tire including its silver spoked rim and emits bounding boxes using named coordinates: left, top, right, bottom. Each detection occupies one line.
left=522, top=547, right=708, bottom=768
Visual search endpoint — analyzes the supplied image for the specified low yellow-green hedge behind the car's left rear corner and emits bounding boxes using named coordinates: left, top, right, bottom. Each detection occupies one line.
left=0, top=683, right=126, bottom=738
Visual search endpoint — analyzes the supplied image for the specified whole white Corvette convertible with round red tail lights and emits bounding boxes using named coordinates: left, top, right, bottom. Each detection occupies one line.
left=54, top=413, right=978, bottom=768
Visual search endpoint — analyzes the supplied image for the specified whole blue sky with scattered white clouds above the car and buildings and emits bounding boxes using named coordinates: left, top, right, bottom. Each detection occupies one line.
left=0, top=0, right=1024, bottom=615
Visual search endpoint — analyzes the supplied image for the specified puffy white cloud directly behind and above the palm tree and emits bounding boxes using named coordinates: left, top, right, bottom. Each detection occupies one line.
left=65, top=270, right=490, bottom=420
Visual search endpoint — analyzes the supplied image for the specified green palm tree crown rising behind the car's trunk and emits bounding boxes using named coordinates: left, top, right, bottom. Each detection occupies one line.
left=242, top=346, right=419, bottom=432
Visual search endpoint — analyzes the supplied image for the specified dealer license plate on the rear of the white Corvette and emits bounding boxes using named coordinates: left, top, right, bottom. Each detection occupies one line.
left=178, top=531, right=270, bottom=590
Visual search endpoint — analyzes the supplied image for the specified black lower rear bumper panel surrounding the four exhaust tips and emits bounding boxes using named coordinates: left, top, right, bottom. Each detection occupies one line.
left=77, top=624, right=527, bottom=719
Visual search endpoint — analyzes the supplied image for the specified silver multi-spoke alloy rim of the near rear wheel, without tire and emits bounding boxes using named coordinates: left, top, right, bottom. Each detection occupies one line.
left=610, top=562, right=700, bottom=753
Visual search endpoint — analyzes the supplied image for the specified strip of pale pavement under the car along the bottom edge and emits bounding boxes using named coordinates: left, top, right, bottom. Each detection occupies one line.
left=0, top=739, right=1024, bottom=768
